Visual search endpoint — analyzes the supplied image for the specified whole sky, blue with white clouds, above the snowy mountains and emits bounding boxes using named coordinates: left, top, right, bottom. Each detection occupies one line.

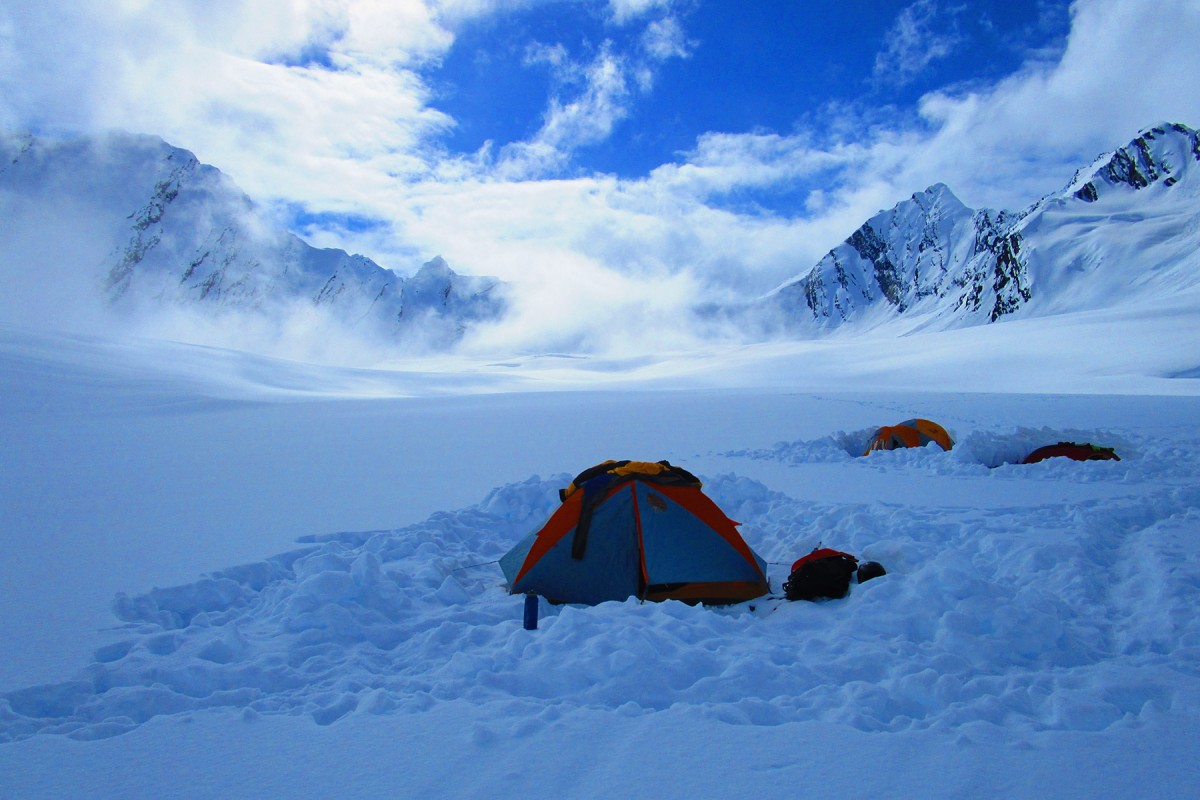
left=0, top=0, right=1200, bottom=344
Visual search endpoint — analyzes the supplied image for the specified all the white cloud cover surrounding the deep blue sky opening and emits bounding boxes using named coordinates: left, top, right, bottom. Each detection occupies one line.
left=0, top=0, right=1200, bottom=362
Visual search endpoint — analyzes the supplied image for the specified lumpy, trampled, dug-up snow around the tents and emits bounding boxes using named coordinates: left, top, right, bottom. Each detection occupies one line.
left=0, top=431, right=1200, bottom=741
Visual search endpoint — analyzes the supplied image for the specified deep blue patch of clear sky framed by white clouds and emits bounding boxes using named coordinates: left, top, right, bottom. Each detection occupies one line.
left=439, top=0, right=1069, bottom=178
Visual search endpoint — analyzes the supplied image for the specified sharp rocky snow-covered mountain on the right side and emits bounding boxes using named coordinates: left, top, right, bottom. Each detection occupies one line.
left=757, top=124, right=1200, bottom=331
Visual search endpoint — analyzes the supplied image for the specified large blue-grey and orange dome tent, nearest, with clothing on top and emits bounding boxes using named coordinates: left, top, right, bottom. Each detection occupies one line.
left=500, top=461, right=768, bottom=604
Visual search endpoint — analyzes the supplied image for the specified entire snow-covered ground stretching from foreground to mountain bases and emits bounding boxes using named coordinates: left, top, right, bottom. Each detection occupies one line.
left=0, top=316, right=1200, bottom=799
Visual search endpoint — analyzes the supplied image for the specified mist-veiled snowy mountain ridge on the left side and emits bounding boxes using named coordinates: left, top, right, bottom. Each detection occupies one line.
left=0, top=133, right=504, bottom=343
